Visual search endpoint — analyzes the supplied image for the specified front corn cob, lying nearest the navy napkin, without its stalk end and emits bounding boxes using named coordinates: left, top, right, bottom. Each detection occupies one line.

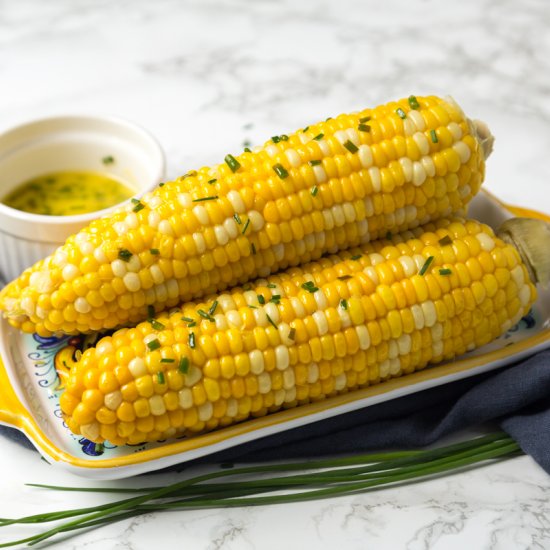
left=61, top=220, right=536, bottom=444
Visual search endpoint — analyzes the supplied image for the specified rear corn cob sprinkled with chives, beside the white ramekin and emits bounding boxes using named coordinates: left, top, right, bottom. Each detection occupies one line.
left=0, top=96, right=491, bottom=336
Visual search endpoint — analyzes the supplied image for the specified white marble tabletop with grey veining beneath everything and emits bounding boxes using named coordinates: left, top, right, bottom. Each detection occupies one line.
left=0, top=0, right=550, bottom=550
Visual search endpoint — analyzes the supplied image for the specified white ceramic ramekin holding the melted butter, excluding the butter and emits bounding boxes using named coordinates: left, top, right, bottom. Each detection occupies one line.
left=0, top=115, right=165, bottom=281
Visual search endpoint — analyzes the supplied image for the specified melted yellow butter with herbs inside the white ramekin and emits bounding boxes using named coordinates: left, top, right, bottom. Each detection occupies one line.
left=2, top=172, right=135, bottom=216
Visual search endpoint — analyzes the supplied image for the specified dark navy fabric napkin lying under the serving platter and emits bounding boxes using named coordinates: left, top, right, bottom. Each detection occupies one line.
left=0, top=350, right=550, bottom=473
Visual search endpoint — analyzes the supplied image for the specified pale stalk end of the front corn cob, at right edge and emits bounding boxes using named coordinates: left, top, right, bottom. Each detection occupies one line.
left=497, top=218, right=550, bottom=288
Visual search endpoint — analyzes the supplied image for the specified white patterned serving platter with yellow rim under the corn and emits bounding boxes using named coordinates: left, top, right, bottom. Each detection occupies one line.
left=0, top=192, right=550, bottom=479
